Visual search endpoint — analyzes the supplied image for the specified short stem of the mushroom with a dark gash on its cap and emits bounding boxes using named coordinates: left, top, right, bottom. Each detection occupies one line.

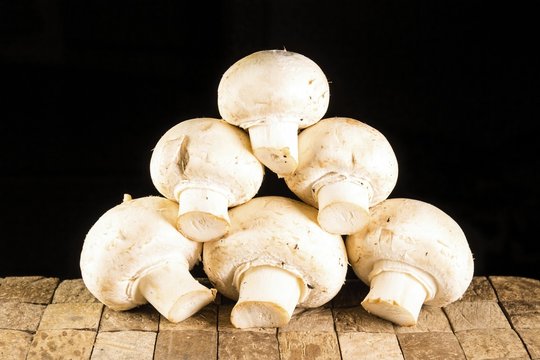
left=178, top=188, right=230, bottom=242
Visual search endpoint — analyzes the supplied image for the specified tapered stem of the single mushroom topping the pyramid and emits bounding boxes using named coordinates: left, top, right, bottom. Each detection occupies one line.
left=248, top=119, right=298, bottom=177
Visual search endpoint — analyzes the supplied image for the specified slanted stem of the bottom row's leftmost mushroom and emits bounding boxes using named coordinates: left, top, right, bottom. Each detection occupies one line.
left=138, top=262, right=216, bottom=322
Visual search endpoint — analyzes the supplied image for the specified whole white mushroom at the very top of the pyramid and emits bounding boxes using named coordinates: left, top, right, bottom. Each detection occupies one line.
left=218, top=50, right=330, bottom=176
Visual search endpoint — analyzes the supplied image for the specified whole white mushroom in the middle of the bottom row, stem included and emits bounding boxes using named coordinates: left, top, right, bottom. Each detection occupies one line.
left=203, top=196, right=347, bottom=328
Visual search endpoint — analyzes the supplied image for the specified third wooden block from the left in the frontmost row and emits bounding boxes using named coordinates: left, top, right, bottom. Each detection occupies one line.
left=91, top=331, right=157, bottom=360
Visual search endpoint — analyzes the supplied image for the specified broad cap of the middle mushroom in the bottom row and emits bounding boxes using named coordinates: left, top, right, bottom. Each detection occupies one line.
left=203, top=196, right=347, bottom=307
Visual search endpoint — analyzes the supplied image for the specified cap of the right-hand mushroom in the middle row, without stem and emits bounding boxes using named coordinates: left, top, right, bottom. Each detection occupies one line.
left=284, top=117, right=398, bottom=207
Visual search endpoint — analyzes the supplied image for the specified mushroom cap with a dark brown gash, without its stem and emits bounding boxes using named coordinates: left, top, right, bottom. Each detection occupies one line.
left=150, top=118, right=264, bottom=206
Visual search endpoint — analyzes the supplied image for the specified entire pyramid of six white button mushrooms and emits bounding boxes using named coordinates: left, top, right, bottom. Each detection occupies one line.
left=80, top=50, right=474, bottom=328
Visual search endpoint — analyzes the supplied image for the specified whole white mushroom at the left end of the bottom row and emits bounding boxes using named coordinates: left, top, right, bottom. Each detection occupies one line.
left=80, top=196, right=216, bottom=322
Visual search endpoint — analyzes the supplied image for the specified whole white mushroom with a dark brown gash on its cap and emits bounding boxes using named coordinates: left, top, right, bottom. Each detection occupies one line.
left=150, top=118, right=264, bottom=242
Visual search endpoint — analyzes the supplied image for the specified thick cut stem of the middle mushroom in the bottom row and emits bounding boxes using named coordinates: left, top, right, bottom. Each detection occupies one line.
left=231, top=265, right=303, bottom=329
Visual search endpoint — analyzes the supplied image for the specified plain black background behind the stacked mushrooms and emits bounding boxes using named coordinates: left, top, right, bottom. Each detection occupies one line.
left=0, top=0, right=540, bottom=278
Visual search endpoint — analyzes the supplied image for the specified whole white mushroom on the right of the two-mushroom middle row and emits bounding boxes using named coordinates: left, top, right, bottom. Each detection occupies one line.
left=285, top=117, right=398, bottom=235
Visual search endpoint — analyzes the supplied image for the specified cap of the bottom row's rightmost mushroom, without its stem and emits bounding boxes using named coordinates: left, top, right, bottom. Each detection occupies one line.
left=346, top=198, right=474, bottom=306
